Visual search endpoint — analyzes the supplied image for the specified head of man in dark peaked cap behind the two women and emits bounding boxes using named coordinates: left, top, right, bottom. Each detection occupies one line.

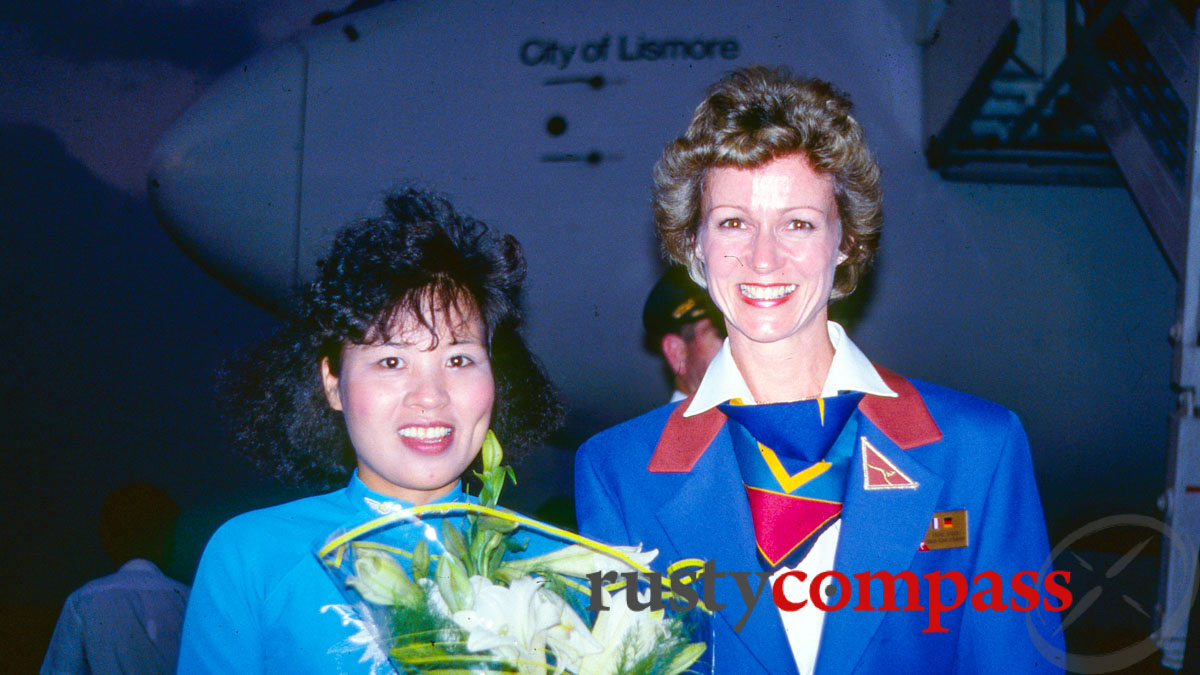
left=642, top=267, right=725, bottom=401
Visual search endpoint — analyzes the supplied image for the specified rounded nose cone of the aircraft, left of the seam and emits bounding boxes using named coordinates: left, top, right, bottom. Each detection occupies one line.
left=149, top=42, right=308, bottom=306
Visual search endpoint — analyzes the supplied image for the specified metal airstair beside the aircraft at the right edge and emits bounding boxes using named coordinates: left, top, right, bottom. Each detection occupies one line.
left=923, top=0, right=1200, bottom=673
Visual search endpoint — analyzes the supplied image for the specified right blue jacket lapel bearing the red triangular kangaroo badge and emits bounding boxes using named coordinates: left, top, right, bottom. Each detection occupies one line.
left=816, top=415, right=944, bottom=675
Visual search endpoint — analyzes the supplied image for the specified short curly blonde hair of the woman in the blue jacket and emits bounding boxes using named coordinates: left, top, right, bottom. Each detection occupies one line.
left=654, top=66, right=883, bottom=299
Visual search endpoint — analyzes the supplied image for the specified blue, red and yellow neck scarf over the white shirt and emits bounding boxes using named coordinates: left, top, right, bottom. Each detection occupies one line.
left=718, top=392, right=863, bottom=572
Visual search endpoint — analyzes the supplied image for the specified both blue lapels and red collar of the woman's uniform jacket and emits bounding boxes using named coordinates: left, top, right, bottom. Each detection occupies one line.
left=647, top=366, right=944, bottom=675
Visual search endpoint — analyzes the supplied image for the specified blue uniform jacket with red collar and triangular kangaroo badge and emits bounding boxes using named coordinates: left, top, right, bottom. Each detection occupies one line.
left=576, top=369, right=1064, bottom=675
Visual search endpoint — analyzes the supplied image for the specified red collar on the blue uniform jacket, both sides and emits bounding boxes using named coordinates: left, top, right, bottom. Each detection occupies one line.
left=647, top=366, right=942, bottom=473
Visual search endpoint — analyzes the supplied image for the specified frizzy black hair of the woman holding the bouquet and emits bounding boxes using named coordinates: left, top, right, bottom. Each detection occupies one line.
left=221, top=187, right=564, bottom=488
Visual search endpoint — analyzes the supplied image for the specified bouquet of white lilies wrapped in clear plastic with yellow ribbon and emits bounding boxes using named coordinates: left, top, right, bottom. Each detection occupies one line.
left=317, top=432, right=712, bottom=675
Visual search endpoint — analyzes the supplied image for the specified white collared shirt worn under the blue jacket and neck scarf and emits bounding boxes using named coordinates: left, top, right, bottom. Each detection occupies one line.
left=684, top=321, right=896, bottom=675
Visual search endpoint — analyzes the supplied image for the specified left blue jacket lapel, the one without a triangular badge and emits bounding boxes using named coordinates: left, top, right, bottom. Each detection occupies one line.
left=658, top=429, right=796, bottom=675
